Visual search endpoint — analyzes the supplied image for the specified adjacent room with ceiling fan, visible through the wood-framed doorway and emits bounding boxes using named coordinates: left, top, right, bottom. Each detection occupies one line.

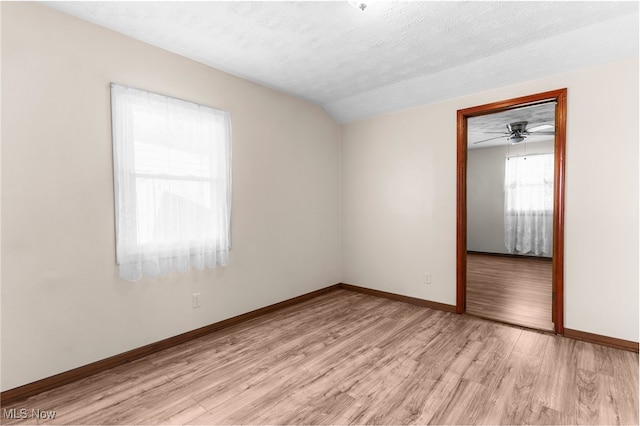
left=466, top=101, right=558, bottom=331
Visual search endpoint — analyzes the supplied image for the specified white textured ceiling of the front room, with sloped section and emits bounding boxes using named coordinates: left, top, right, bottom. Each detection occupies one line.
left=44, top=1, right=638, bottom=122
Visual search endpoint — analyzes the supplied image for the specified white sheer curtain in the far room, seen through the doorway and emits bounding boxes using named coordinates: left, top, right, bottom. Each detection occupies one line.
left=504, top=154, right=554, bottom=256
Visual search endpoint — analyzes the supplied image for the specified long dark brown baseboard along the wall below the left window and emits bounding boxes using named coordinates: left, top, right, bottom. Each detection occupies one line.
left=0, top=284, right=340, bottom=406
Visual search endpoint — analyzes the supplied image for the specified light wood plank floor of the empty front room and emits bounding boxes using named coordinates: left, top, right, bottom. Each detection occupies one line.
left=3, top=290, right=638, bottom=425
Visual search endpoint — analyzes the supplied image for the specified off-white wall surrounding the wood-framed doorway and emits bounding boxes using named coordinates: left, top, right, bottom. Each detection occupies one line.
left=341, top=57, right=639, bottom=342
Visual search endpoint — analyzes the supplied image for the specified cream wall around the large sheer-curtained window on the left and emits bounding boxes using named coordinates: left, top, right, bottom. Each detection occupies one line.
left=0, top=2, right=340, bottom=390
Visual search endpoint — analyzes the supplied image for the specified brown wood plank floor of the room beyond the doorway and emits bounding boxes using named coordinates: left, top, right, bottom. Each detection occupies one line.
left=467, top=253, right=554, bottom=331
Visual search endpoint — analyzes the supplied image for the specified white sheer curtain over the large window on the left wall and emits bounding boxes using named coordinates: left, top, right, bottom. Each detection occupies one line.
left=111, top=84, right=231, bottom=281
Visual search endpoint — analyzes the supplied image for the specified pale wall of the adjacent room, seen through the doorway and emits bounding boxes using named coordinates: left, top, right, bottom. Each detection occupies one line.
left=467, top=140, right=553, bottom=253
